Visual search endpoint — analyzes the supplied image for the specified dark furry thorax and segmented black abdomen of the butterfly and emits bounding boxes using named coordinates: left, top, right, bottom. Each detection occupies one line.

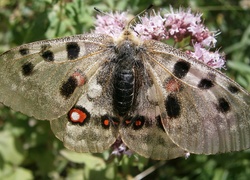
left=113, top=40, right=141, bottom=116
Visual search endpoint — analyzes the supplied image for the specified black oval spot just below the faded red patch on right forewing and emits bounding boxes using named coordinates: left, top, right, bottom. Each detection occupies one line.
left=165, top=94, right=181, bottom=118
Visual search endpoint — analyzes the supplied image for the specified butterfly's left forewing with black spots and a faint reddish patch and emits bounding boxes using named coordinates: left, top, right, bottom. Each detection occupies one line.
left=0, top=34, right=113, bottom=120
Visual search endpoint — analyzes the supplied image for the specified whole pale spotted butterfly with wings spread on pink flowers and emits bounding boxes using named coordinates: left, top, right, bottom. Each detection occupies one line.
left=0, top=11, right=250, bottom=160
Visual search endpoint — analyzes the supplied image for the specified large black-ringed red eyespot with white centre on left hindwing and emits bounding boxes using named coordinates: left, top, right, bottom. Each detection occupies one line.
left=68, top=107, right=90, bottom=124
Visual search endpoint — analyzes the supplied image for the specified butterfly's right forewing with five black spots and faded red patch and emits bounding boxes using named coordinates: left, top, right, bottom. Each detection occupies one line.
left=145, top=41, right=250, bottom=154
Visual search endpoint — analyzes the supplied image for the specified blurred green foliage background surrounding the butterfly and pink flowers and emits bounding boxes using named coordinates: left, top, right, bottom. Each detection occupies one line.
left=0, top=0, right=250, bottom=180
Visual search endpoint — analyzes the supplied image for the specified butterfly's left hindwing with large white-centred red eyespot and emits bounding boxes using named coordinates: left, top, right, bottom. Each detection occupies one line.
left=50, top=67, right=119, bottom=153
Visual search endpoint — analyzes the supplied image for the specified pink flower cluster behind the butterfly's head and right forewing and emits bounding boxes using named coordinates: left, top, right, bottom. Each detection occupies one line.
left=94, top=7, right=225, bottom=68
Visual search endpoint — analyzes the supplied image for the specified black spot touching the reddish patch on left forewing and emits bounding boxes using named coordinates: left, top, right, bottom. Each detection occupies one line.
left=60, top=76, right=78, bottom=98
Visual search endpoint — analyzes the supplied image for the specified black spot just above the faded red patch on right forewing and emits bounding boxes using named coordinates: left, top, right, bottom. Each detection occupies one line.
left=173, top=61, right=190, bottom=79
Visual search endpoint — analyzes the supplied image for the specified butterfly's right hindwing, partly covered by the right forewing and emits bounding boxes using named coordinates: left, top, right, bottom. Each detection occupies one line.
left=119, top=59, right=185, bottom=160
